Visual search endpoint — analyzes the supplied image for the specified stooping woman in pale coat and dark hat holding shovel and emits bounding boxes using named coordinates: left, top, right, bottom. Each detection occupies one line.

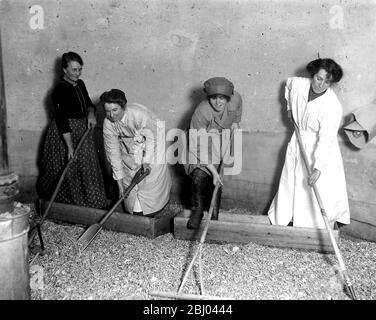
left=100, top=89, right=171, bottom=216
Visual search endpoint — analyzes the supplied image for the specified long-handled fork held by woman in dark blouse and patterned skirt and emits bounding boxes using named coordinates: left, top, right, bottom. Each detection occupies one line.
left=28, top=127, right=92, bottom=250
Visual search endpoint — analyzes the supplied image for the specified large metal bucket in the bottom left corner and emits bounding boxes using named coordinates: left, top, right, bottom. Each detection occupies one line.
left=0, top=207, right=30, bottom=300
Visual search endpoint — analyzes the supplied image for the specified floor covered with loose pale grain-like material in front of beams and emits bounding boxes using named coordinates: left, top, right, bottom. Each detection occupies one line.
left=29, top=205, right=376, bottom=300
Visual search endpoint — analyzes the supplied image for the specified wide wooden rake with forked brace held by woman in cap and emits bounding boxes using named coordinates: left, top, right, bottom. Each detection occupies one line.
left=150, top=130, right=234, bottom=300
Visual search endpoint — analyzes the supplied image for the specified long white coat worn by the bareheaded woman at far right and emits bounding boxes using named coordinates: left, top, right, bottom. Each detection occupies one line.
left=268, top=77, right=350, bottom=228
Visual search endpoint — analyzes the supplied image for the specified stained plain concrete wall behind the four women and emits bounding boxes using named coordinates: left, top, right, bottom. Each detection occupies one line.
left=0, top=0, right=376, bottom=240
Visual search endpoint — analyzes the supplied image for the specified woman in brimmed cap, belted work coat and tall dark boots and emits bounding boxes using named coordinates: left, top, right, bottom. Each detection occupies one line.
left=185, top=77, right=242, bottom=229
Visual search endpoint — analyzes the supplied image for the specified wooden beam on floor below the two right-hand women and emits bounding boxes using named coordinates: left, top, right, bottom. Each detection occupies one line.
left=174, top=211, right=339, bottom=253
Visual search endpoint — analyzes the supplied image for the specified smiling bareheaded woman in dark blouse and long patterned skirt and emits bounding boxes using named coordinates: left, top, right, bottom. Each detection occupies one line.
left=39, top=52, right=106, bottom=208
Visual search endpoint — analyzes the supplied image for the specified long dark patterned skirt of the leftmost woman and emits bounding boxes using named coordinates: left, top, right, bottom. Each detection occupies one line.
left=38, top=119, right=107, bottom=208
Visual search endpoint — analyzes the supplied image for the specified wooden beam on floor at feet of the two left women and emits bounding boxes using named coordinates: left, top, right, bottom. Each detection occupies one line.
left=42, top=201, right=176, bottom=239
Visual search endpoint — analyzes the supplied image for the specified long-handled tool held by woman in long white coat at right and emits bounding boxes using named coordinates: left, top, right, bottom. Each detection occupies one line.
left=293, top=119, right=356, bottom=300
